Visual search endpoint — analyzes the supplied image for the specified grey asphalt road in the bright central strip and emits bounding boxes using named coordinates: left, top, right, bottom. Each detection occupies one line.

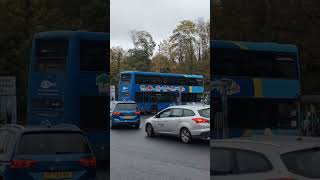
left=104, top=116, right=210, bottom=180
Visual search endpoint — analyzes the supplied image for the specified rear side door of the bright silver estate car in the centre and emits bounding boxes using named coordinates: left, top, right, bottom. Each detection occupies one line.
left=164, top=108, right=183, bottom=134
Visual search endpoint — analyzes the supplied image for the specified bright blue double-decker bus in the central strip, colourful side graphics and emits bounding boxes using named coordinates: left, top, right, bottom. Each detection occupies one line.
left=118, top=71, right=204, bottom=113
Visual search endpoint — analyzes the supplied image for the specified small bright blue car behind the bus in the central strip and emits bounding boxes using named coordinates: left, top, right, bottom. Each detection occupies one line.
left=110, top=101, right=140, bottom=129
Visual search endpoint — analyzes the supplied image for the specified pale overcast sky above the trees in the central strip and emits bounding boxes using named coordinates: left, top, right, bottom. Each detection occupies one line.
left=110, top=0, right=210, bottom=49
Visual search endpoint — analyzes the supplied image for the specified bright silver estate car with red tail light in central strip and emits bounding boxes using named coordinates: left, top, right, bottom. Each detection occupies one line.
left=145, top=104, right=210, bottom=143
